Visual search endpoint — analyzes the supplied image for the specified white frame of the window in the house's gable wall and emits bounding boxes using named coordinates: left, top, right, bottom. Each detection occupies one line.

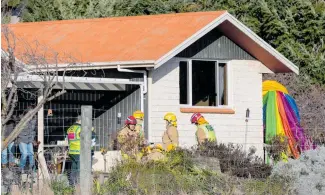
left=179, top=59, right=233, bottom=109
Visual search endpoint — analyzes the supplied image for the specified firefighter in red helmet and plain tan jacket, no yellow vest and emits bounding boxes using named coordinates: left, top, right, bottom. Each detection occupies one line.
left=117, top=116, right=143, bottom=161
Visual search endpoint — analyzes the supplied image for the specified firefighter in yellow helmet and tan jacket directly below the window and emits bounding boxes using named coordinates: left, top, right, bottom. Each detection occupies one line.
left=162, top=113, right=178, bottom=151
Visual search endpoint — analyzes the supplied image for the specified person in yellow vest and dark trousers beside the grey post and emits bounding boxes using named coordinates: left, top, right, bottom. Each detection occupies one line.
left=67, top=116, right=94, bottom=185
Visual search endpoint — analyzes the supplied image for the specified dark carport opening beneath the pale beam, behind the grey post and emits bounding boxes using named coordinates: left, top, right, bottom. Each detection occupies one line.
left=44, top=85, right=141, bottom=151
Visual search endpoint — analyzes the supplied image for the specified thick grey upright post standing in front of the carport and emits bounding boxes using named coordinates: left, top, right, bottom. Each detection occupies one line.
left=80, top=106, right=93, bottom=195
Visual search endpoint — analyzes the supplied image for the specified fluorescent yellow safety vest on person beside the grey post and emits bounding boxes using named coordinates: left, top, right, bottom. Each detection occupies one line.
left=67, top=124, right=81, bottom=154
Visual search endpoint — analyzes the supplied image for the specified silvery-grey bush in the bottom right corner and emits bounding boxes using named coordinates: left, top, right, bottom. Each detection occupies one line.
left=271, top=147, right=325, bottom=195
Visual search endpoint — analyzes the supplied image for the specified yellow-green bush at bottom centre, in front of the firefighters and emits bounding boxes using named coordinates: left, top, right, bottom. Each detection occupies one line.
left=98, top=150, right=234, bottom=194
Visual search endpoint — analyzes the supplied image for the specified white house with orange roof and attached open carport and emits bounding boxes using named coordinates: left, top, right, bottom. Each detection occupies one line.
left=2, top=11, right=299, bottom=168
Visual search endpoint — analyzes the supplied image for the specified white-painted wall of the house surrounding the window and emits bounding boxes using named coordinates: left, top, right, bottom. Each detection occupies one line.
left=149, top=58, right=264, bottom=156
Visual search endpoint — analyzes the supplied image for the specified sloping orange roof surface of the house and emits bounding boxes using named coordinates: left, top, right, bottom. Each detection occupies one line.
left=1, top=11, right=226, bottom=63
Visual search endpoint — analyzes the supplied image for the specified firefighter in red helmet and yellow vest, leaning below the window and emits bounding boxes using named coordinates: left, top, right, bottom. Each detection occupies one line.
left=191, top=113, right=217, bottom=145
